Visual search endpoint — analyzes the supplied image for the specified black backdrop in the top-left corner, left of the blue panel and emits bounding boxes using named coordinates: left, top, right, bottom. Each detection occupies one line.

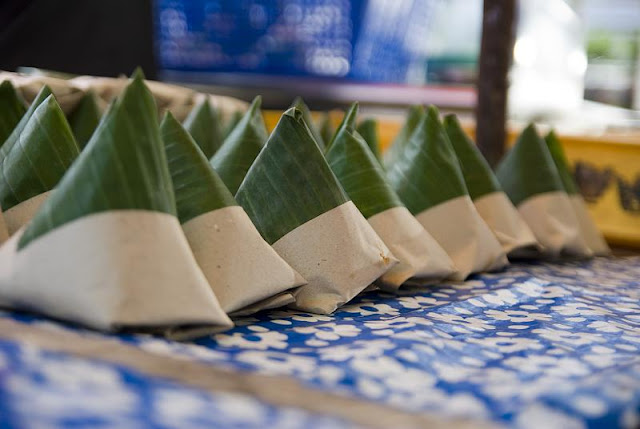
left=0, top=0, right=156, bottom=78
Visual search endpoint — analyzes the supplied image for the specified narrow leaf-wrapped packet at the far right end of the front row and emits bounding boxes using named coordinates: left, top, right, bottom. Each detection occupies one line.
left=545, top=131, right=611, bottom=256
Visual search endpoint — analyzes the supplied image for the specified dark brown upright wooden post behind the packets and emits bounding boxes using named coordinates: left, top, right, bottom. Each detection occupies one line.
left=476, top=0, right=515, bottom=167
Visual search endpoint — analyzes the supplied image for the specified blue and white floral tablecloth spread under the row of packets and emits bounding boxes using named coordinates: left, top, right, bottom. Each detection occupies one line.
left=0, top=257, right=640, bottom=428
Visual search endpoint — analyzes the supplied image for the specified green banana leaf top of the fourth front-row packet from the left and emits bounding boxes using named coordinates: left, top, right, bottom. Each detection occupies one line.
left=325, top=104, right=402, bottom=219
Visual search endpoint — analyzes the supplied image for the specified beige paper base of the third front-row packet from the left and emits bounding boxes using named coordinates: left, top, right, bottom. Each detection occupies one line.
left=273, top=201, right=398, bottom=314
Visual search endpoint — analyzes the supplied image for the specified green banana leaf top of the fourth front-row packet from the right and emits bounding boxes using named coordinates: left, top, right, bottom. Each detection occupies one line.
left=387, top=106, right=468, bottom=215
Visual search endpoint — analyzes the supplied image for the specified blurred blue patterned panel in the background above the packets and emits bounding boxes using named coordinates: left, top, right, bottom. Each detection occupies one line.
left=155, top=0, right=436, bottom=83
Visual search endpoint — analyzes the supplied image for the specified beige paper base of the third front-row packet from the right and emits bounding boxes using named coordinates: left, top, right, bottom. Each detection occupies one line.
left=473, top=192, right=538, bottom=255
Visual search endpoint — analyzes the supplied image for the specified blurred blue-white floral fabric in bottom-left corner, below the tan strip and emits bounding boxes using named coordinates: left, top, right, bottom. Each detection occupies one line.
left=0, top=341, right=355, bottom=429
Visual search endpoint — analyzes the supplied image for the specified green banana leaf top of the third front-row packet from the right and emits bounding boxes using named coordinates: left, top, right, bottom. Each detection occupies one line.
left=443, top=115, right=502, bottom=200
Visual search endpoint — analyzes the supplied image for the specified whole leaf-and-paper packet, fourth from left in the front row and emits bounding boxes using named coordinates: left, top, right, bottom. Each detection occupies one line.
left=326, top=103, right=455, bottom=291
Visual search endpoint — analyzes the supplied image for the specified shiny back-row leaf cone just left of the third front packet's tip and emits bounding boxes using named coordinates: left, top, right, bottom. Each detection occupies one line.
left=211, top=96, right=269, bottom=194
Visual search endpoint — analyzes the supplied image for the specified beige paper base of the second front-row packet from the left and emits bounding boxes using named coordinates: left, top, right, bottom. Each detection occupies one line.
left=182, top=206, right=306, bottom=314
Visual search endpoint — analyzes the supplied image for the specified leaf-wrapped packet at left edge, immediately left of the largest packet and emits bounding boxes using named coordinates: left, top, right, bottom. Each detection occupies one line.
left=0, top=87, right=80, bottom=235
